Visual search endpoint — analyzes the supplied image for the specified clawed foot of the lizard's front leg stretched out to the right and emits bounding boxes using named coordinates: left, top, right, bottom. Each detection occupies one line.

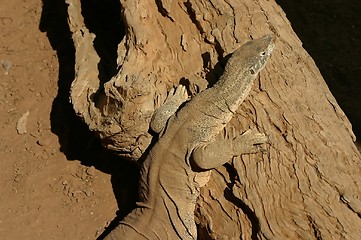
left=233, top=130, right=269, bottom=155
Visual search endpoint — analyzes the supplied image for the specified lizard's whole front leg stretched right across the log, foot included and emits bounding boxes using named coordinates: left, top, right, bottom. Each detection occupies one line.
left=192, top=130, right=268, bottom=170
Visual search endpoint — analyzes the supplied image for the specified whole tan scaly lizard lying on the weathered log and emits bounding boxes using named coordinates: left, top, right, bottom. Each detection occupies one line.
left=105, top=34, right=275, bottom=240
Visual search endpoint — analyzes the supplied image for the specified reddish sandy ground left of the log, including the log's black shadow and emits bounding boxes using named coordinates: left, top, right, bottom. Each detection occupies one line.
left=0, top=0, right=358, bottom=240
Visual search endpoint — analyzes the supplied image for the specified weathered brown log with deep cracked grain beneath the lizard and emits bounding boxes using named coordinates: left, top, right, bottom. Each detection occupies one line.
left=67, top=0, right=361, bottom=239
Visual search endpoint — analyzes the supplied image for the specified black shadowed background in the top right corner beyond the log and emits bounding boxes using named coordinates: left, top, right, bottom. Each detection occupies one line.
left=276, top=0, right=361, bottom=138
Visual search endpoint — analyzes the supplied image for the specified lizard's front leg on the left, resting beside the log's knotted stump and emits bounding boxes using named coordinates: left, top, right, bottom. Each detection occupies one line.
left=150, top=85, right=188, bottom=133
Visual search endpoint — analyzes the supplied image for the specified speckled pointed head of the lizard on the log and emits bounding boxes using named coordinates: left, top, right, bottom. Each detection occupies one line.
left=232, top=34, right=276, bottom=76
